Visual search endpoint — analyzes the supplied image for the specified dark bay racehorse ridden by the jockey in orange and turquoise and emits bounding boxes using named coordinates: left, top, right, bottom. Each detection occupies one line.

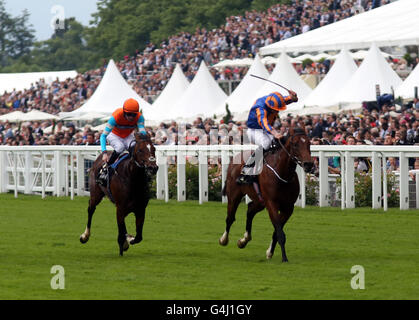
left=80, top=134, right=158, bottom=256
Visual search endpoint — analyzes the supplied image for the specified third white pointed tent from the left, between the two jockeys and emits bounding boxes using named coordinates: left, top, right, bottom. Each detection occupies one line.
left=170, top=61, right=227, bottom=120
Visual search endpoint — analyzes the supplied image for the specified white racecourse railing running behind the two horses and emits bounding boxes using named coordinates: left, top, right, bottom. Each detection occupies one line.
left=0, top=145, right=419, bottom=210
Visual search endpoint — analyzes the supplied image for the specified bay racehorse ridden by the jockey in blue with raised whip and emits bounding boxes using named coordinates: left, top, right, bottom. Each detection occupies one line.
left=219, top=127, right=313, bottom=262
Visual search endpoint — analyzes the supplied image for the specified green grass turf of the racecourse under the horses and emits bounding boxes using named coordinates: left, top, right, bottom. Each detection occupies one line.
left=0, top=194, right=419, bottom=300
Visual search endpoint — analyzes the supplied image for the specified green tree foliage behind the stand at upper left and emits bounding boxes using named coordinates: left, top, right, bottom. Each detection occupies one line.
left=0, top=0, right=289, bottom=72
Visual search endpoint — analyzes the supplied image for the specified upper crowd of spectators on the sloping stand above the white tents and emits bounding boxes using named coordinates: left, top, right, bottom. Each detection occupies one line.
left=0, top=0, right=398, bottom=114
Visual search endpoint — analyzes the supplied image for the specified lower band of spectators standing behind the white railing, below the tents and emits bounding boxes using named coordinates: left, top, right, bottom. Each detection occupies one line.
left=0, top=92, right=419, bottom=172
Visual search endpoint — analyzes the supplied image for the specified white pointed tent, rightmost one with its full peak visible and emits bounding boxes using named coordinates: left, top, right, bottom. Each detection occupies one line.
left=335, top=44, right=402, bottom=103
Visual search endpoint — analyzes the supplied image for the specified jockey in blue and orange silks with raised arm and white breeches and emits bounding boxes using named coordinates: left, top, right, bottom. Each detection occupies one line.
left=236, top=90, right=298, bottom=184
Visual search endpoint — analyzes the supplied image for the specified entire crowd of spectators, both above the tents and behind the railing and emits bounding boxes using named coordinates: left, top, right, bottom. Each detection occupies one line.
left=0, top=0, right=419, bottom=175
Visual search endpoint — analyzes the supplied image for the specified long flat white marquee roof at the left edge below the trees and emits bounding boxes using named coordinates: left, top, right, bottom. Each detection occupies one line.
left=0, top=70, right=77, bottom=94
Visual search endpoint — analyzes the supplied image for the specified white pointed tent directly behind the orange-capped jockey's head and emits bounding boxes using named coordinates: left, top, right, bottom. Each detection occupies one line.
left=66, top=60, right=151, bottom=120
